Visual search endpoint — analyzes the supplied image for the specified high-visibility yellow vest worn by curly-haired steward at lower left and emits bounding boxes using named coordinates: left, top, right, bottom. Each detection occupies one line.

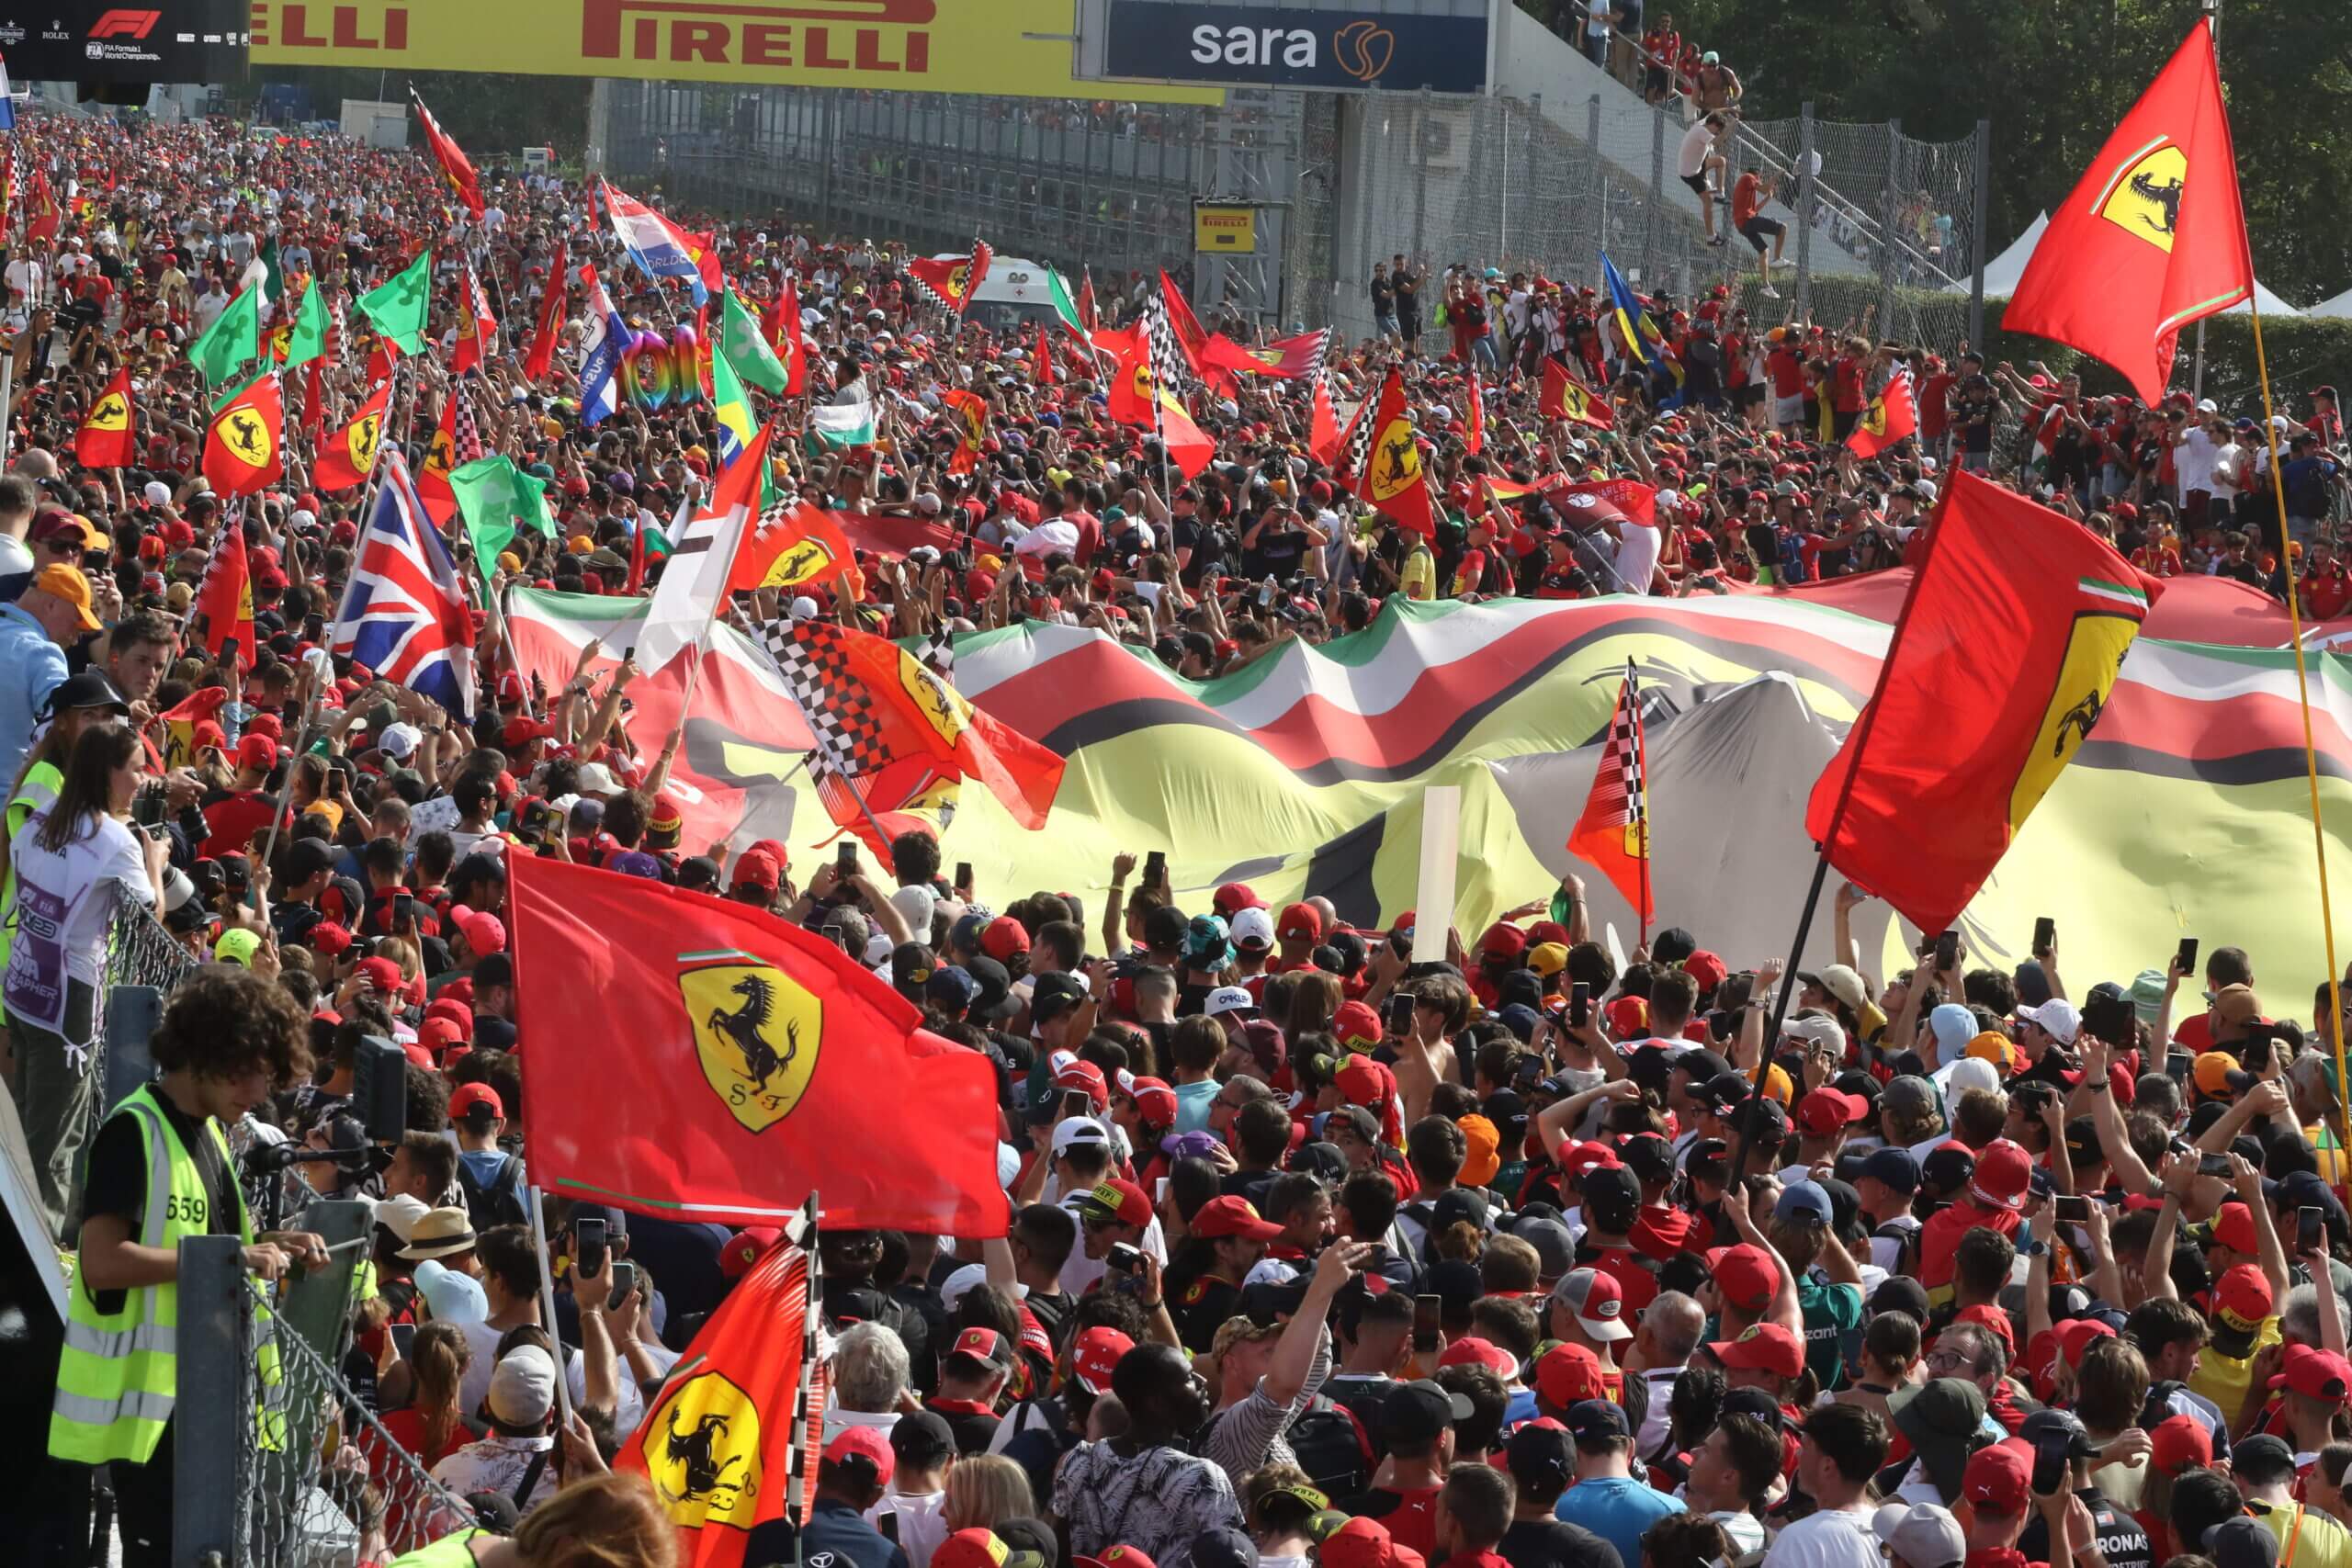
left=50, top=1086, right=259, bottom=1464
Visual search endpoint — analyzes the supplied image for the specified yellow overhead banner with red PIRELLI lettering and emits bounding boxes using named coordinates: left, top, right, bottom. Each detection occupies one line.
left=252, top=0, right=1223, bottom=104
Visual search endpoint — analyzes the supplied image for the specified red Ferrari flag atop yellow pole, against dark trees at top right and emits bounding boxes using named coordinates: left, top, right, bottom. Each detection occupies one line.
left=2002, top=21, right=2253, bottom=402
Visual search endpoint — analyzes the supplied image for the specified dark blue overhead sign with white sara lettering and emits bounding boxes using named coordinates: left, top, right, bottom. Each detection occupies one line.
left=1103, top=0, right=1487, bottom=92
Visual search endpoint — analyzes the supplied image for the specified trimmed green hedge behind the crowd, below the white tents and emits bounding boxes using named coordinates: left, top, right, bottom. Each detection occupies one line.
left=1743, top=277, right=2352, bottom=419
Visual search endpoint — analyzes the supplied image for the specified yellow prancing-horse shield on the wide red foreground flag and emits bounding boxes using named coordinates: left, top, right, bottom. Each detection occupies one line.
left=677, top=952, right=826, bottom=1133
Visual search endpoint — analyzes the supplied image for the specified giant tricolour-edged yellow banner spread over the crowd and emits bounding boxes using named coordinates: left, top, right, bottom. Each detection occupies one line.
left=515, top=585, right=2352, bottom=1010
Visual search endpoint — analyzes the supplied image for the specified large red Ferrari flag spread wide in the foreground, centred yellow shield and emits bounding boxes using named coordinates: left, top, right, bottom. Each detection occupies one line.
left=508, top=860, right=1009, bottom=1236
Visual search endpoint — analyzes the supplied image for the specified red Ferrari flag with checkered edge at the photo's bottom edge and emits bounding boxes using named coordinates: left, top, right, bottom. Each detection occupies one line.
left=612, top=1241, right=832, bottom=1568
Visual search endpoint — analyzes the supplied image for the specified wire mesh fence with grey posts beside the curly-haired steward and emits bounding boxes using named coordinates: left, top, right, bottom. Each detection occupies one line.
left=172, top=1201, right=475, bottom=1568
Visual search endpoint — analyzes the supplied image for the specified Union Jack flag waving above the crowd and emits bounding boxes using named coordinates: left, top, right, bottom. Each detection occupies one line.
left=332, top=442, right=473, bottom=719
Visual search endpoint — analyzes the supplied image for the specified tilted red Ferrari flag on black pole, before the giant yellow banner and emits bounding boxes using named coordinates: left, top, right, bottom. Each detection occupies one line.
left=1804, top=472, right=2162, bottom=931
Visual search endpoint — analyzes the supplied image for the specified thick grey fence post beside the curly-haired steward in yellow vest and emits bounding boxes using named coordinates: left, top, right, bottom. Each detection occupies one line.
left=172, top=1236, right=254, bottom=1568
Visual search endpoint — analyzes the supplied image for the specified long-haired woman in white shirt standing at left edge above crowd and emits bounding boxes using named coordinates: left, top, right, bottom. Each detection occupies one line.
left=0, top=724, right=169, bottom=1236
